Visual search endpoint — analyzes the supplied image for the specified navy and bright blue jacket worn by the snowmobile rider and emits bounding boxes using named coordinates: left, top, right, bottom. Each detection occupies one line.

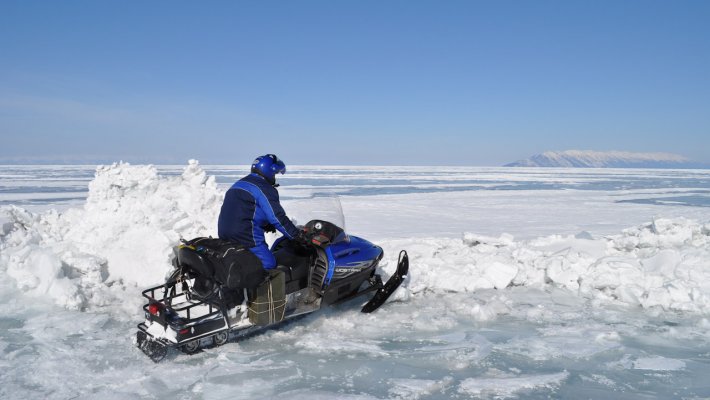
left=217, top=173, right=299, bottom=250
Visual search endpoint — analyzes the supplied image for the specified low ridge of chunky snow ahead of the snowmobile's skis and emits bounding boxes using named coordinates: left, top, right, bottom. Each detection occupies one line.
left=387, top=218, right=710, bottom=313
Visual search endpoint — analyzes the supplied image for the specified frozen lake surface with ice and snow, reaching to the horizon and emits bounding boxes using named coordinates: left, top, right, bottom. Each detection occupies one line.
left=0, top=164, right=710, bottom=399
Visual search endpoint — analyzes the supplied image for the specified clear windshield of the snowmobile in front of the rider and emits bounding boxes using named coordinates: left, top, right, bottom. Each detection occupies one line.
left=287, top=193, right=349, bottom=243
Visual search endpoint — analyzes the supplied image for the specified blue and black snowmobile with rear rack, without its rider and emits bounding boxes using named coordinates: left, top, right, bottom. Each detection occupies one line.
left=135, top=198, right=409, bottom=362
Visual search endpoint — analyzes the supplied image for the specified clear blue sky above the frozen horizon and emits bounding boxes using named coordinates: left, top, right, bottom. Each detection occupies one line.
left=0, top=0, right=710, bottom=165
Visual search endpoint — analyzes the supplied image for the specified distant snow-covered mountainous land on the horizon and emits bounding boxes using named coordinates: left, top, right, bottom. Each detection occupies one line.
left=505, top=150, right=710, bottom=168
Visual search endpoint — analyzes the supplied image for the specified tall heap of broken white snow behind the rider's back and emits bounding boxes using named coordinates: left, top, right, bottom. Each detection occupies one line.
left=0, top=160, right=223, bottom=309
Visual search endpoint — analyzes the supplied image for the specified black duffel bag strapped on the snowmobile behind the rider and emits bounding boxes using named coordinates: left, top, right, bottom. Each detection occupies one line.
left=177, top=237, right=266, bottom=290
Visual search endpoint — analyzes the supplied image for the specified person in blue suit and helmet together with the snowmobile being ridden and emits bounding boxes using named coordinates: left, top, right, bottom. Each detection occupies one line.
left=136, top=161, right=409, bottom=362
